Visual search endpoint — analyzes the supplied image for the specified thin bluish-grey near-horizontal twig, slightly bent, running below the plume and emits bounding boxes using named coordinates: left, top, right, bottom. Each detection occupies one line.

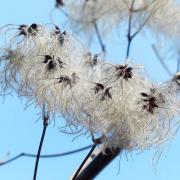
left=0, top=145, right=93, bottom=166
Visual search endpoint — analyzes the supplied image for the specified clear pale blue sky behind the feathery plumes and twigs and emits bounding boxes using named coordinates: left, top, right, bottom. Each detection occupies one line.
left=0, top=0, right=180, bottom=180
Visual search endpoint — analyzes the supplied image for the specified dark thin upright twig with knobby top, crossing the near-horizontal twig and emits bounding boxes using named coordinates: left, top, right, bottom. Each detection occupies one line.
left=33, top=104, right=49, bottom=180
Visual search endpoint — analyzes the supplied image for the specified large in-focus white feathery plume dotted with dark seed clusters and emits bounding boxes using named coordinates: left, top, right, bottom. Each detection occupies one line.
left=0, top=24, right=180, bottom=150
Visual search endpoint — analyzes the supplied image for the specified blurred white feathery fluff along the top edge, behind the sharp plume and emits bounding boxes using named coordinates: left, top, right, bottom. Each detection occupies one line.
left=65, top=0, right=180, bottom=38
